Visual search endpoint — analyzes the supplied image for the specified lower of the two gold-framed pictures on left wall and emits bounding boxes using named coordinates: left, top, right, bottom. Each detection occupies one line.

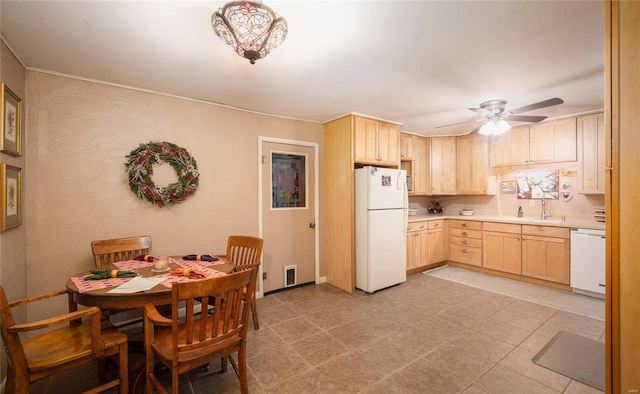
left=0, top=163, right=22, bottom=231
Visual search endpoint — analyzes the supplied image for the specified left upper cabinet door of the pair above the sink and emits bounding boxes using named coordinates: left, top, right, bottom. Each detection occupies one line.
left=491, top=126, right=529, bottom=167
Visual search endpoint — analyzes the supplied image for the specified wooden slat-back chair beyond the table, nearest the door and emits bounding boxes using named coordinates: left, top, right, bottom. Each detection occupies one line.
left=223, top=235, right=263, bottom=330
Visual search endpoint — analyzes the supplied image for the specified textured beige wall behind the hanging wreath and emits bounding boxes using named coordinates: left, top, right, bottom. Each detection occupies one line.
left=25, top=71, right=324, bottom=314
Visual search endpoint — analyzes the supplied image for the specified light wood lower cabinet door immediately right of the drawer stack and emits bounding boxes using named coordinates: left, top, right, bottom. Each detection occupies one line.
left=482, top=231, right=522, bottom=275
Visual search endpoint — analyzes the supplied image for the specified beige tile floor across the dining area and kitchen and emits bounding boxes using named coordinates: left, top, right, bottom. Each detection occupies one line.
left=32, top=267, right=604, bottom=394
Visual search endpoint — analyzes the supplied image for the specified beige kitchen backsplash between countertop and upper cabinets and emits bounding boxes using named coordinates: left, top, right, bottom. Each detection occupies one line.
left=409, top=166, right=604, bottom=220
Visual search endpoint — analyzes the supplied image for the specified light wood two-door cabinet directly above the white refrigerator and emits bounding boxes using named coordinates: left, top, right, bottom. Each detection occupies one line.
left=354, top=116, right=400, bottom=168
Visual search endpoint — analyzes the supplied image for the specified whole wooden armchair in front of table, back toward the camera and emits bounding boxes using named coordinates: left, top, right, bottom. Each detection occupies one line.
left=144, top=269, right=256, bottom=394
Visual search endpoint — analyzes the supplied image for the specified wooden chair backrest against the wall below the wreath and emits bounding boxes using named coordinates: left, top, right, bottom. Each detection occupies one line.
left=91, top=235, right=151, bottom=268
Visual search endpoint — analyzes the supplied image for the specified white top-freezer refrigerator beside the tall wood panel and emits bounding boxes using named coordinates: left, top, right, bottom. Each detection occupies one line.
left=355, top=167, right=408, bottom=293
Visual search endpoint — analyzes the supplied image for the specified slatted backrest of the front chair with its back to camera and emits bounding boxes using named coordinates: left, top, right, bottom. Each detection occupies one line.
left=172, top=269, right=256, bottom=360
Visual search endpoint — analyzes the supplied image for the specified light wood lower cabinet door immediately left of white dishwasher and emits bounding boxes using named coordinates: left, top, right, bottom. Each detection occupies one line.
left=522, top=235, right=570, bottom=285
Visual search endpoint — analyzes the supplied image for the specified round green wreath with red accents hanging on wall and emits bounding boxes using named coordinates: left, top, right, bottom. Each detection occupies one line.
left=125, top=142, right=199, bottom=207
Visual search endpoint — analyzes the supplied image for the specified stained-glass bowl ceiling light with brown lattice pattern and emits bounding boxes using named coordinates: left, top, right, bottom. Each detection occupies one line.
left=211, top=1, right=287, bottom=64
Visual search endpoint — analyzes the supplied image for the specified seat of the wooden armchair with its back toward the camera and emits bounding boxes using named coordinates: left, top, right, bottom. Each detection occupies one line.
left=152, top=316, right=241, bottom=371
